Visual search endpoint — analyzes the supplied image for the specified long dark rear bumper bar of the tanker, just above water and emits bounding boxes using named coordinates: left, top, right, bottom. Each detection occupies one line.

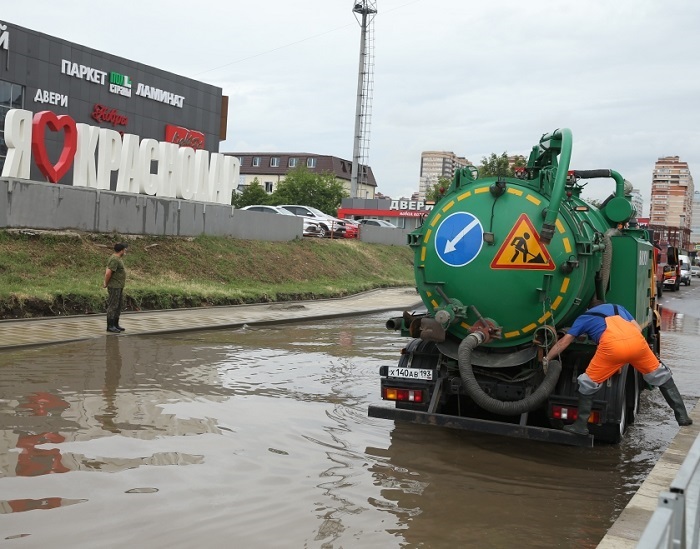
left=367, top=405, right=593, bottom=448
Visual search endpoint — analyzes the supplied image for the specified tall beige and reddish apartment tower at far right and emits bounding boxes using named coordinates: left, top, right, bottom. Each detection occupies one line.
left=649, top=156, right=695, bottom=250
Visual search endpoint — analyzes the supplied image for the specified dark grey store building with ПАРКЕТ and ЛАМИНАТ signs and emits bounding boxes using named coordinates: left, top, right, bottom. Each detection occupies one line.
left=0, top=22, right=228, bottom=188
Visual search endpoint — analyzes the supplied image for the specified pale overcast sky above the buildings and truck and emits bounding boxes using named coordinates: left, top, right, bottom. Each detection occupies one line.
left=0, top=0, right=700, bottom=213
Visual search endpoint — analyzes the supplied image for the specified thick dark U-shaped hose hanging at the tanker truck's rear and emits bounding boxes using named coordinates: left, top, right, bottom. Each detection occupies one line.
left=457, top=334, right=561, bottom=416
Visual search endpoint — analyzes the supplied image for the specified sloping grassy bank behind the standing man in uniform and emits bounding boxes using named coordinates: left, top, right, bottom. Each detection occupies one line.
left=0, top=230, right=414, bottom=318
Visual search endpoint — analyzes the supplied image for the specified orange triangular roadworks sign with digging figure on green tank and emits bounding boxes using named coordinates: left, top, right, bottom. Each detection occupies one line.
left=491, top=214, right=556, bottom=271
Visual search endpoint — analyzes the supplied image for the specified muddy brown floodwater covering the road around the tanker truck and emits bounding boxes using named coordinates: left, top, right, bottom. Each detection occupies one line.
left=0, top=288, right=700, bottom=549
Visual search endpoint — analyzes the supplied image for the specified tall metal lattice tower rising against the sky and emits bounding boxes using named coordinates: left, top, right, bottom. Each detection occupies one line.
left=350, top=0, right=377, bottom=198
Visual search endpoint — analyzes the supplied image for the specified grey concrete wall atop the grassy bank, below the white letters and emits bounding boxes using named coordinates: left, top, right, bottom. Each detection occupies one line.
left=0, top=179, right=408, bottom=245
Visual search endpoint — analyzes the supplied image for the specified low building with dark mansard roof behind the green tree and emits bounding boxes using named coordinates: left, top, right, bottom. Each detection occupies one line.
left=224, top=152, right=377, bottom=199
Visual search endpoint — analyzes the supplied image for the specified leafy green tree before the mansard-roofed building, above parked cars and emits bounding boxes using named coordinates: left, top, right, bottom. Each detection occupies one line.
left=271, top=165, right=348, bottom=215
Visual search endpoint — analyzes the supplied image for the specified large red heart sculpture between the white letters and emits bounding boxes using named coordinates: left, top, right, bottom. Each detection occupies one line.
left=32, top=111, right=78, bottom=183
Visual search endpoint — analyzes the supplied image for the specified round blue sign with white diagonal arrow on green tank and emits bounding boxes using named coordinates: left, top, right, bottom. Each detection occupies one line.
left=435, top=212, right=484, bottom=267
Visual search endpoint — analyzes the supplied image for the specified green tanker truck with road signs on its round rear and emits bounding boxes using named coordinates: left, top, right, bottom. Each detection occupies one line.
left=369, top=129, right=660, bottom=445
